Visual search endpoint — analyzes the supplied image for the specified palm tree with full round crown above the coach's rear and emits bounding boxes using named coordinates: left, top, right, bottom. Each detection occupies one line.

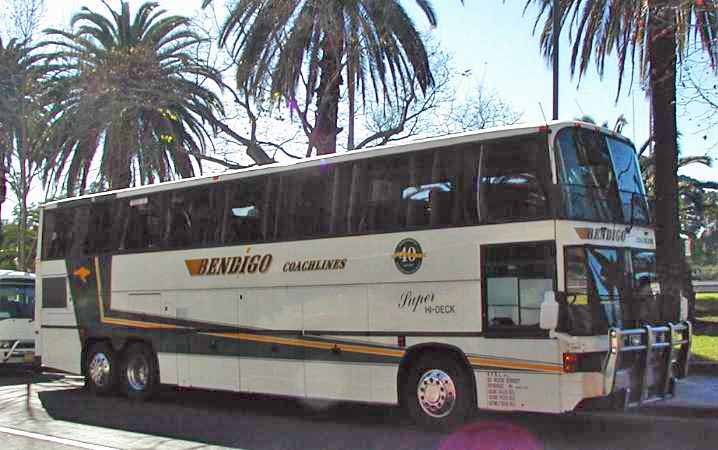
left=44, top=1, right=223, bottom=195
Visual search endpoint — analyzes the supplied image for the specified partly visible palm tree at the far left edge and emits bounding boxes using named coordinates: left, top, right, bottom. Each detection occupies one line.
left=0, top=39, right=51, bottom=270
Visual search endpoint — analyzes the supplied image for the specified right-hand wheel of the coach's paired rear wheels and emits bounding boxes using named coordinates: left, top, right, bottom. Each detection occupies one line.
left=122, top=343, right=159, bottom=401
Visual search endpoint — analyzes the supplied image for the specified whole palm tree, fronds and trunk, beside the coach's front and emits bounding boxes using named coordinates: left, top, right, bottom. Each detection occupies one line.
left=526, top=0, right=718, bottom=317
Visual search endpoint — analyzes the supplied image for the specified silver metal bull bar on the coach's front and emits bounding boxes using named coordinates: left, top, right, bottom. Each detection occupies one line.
left=603, top=321, right=692, bottom=408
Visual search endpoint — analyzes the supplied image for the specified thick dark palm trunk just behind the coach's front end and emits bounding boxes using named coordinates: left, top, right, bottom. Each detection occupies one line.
left=648, top=0, right=683, bottom=321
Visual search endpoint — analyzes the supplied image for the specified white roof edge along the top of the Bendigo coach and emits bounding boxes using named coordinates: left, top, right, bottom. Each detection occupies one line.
left=40, top=121, right=626, bottom=209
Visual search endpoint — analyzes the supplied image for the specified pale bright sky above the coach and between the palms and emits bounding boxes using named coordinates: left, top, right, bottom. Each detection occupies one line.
left=0, top=0, right=718, bottom=219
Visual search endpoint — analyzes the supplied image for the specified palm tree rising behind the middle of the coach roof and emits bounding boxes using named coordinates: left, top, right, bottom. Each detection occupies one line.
left=203, top=0, right=436, bottom=154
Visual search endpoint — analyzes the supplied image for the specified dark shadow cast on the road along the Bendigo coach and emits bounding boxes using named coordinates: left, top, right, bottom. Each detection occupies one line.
left=32, top=382, right=680, bottom=450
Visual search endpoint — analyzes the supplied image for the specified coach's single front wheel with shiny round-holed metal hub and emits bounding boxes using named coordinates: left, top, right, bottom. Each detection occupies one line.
left=403, top=353, right=475, bottom=430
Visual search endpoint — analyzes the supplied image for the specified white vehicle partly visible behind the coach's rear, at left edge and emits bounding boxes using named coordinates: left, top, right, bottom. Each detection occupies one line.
left=0, top=270, right=35, bottom=367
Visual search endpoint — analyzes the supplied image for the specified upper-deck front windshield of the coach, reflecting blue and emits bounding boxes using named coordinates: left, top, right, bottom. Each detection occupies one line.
left=557, top=128, right=650, bottom=225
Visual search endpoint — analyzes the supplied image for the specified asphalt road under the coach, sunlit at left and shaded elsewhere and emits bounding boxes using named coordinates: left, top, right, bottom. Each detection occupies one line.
left=0, top=372, right=718, bottom=450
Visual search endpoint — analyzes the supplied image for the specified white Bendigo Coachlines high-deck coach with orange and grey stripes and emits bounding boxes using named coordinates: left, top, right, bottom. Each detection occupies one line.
left=38, top=122, right=690, bottom=427
